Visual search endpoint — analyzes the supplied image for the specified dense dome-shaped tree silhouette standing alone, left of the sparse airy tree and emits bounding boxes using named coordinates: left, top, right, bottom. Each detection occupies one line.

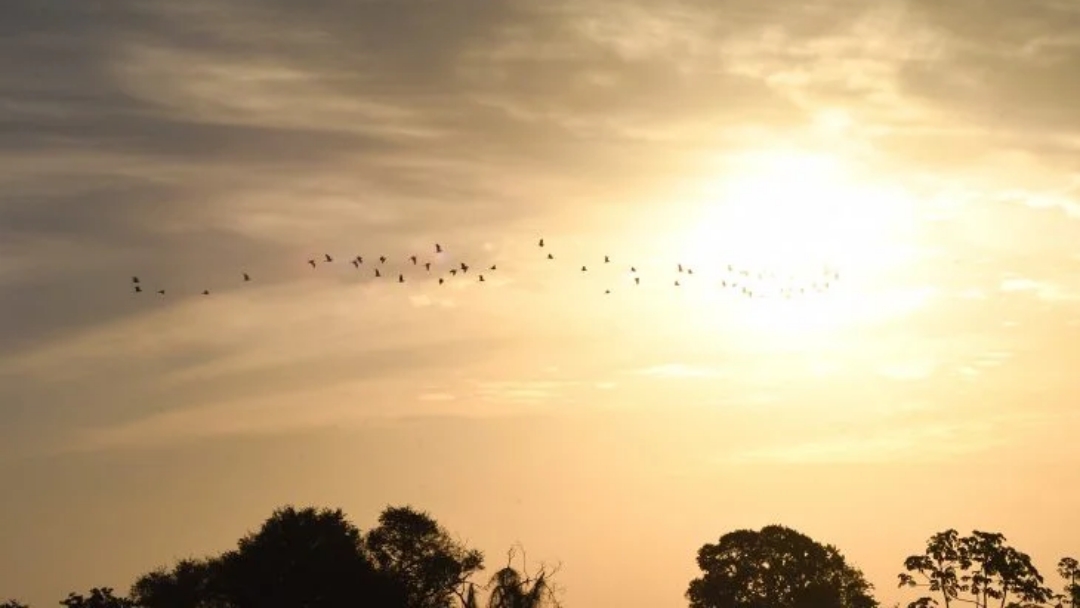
left=686, top=525, right=877, bottom=608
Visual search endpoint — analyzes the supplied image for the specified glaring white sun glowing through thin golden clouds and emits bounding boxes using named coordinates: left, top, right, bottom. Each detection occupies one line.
left=679, top=150, right=913, bottom=334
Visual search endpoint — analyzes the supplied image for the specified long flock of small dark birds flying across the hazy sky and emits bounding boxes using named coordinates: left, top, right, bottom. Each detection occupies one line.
left=132, top=238, right=840, bottom=299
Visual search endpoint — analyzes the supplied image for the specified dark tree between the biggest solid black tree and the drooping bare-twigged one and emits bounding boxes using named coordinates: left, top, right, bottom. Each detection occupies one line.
left=364, top=506, right=484, bottom=608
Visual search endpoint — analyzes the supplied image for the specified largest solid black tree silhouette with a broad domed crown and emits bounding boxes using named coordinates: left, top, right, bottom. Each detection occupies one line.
left=208, top=506, right=405, bottom=608
